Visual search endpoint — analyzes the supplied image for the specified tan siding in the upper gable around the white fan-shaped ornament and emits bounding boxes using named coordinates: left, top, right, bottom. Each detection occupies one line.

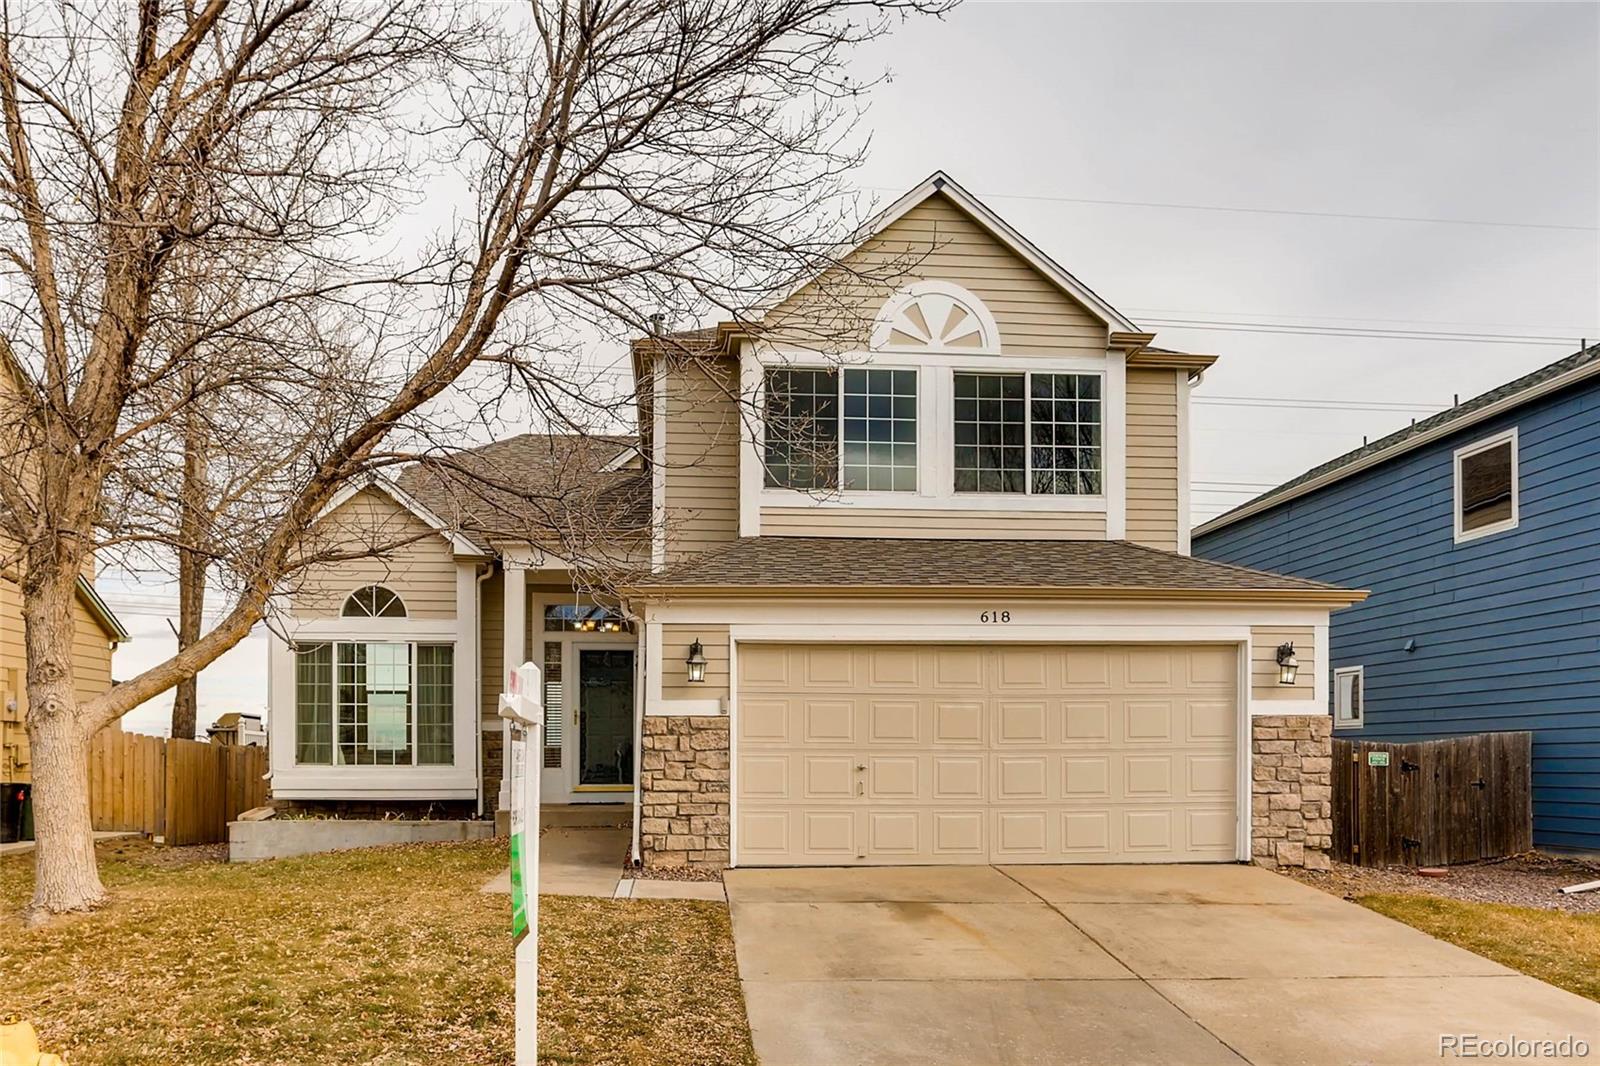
left=765, top=195, right=1107, bottom=355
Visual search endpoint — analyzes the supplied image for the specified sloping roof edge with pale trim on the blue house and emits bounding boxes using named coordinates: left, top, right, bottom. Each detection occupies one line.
left=1194, top=344, right=1600, bottom=536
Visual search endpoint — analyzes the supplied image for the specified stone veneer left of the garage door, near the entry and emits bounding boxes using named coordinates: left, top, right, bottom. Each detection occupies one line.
left=638, top=715, right=730, bottom=869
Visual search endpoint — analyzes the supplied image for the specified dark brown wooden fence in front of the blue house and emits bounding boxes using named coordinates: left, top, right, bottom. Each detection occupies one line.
left=1333, top=733, right=1533, bottom=866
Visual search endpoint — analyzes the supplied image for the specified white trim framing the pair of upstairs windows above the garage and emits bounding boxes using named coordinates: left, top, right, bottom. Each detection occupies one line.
left=752, top=346, right=1125, bottom=508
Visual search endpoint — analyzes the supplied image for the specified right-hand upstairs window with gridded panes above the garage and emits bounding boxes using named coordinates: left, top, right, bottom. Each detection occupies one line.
left=954, top=373, right=1102, bottom=496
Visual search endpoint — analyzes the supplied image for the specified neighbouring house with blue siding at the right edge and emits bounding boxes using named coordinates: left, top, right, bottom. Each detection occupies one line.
left=1194, top=344, right=1600, bottom=852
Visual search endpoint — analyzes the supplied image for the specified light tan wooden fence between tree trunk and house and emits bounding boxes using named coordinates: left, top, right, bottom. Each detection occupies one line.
left=90, top=730, right=267, bottom=844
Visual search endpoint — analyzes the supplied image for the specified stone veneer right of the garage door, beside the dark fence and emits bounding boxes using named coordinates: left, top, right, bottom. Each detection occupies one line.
left=1250, top=714, right=1333, bottom=869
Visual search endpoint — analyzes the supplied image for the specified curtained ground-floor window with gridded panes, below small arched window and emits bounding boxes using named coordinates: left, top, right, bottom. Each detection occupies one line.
left=294, top=640, right=454, bottom=767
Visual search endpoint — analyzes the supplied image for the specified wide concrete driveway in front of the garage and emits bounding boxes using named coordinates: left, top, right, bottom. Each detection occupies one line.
left=726, top=866, right=1600, bottom=1066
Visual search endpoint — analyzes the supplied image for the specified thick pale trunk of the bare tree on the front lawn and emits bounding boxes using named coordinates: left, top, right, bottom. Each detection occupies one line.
left=24, top=568, right=106, bottom=925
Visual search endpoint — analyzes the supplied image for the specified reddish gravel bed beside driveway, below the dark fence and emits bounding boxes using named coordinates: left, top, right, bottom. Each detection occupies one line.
left=1290, top=852, right=1600, bottom=914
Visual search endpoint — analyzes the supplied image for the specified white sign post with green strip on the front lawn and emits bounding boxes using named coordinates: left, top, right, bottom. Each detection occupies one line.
left=499, top=663, right=544, bottom=1066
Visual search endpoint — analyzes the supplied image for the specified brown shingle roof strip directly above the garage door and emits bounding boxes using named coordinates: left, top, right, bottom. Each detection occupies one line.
left=637, top=536, right=1342, bottom=594
